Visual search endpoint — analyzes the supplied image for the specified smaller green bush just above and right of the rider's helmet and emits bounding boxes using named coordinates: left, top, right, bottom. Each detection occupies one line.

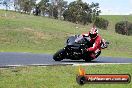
left=94, top=17, right=109, bottom=30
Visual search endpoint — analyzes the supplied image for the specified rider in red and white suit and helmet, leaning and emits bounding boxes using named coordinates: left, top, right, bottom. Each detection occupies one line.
left=82, top=27, right=102, bottom=59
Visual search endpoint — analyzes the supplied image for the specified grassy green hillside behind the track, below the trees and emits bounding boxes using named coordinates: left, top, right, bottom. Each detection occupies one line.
left=0, top=10, right=132, bottom=58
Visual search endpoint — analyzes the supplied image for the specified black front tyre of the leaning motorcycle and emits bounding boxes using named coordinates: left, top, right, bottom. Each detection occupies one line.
left=53, top=49, right=65, bottom=61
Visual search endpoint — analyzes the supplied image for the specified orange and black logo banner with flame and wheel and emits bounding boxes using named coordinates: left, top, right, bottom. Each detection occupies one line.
left=76, top=67, right=131, bottom=85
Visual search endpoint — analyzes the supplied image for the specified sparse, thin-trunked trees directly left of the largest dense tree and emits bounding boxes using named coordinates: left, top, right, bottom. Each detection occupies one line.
left=37, top=0, right=67, bottom=19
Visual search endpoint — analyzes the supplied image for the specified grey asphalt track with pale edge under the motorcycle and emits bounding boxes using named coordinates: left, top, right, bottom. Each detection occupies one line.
left=0, top=52, right=132, bottom=67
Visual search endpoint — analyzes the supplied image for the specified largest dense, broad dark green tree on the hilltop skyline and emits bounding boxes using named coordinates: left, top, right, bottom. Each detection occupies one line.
left=63, top=0, right=101, bottom=25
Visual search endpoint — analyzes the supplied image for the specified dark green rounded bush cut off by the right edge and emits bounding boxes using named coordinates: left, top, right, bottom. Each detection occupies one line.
left=115, top=21, right=132, bottom=35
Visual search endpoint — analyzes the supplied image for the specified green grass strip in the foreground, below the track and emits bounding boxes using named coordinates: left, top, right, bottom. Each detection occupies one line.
left=0, top=64, right=132, bottom=88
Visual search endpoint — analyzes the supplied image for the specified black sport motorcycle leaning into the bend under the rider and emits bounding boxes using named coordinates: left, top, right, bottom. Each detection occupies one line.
left=53, top=35, right=109, bottom=62
